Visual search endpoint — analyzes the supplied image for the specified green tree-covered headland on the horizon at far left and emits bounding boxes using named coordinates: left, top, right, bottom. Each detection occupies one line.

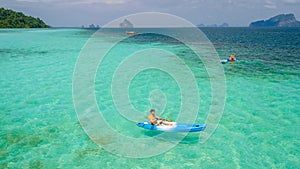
left=0, top=8, right=49, bottom=28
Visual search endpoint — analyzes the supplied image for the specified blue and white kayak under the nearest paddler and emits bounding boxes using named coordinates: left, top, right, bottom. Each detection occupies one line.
left=136, top=121, right=206, bottom=132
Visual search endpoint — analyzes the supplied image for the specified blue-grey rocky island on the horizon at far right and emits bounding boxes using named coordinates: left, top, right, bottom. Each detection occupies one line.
left=249, top=14, right=300, bottom=27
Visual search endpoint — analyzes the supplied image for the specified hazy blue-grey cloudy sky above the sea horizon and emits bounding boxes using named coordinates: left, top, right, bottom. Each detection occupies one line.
left=0, top=0, right=300, bottom=27
